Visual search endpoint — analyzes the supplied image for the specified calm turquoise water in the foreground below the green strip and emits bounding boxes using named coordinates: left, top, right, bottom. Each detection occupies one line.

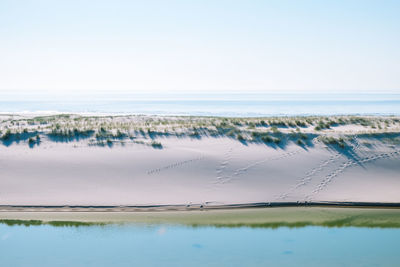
left=0, top=225, right=400, bottom=266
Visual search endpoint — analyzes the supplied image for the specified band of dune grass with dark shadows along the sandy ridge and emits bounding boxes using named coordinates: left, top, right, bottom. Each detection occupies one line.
left=0, top=114, right=400, bottom=148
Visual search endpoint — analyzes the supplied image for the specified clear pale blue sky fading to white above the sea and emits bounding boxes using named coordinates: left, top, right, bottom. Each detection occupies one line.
left=0, top=0, right=400, bottom=94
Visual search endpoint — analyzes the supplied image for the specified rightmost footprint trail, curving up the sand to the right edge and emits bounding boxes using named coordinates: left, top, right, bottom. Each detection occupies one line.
left=306, top=150, right=400, bottom=200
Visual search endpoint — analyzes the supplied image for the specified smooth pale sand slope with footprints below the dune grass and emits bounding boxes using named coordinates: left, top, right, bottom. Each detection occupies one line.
left=0, top=137, right=400, bottom=205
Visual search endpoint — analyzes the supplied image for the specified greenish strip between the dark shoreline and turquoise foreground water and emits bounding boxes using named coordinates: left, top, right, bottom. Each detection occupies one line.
left=0, top=207, right=400, bottom=228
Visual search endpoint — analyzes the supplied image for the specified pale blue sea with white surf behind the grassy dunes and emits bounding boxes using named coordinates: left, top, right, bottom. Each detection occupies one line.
left=0, top=94, right=400, bottom=116
